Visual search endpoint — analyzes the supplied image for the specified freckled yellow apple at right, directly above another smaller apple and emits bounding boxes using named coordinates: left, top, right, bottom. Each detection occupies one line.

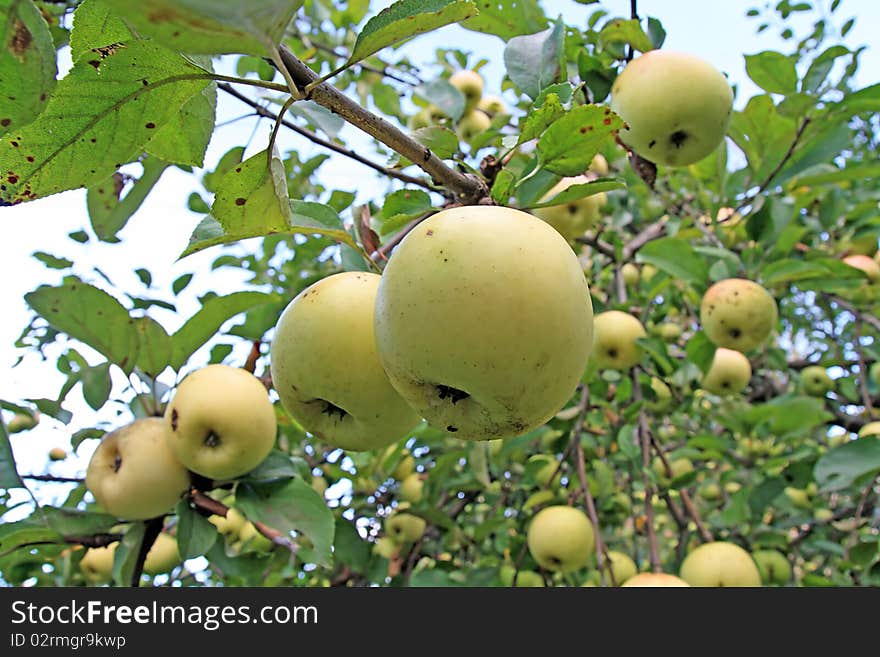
left=700, top=278, right=779, bottom=352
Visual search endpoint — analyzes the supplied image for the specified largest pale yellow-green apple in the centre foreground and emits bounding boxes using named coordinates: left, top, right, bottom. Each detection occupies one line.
left=376, top=206, right=593, bottom=440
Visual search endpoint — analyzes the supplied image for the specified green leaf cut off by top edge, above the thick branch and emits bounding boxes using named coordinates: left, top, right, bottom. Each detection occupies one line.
left=105, top=0, right=303, bottom=55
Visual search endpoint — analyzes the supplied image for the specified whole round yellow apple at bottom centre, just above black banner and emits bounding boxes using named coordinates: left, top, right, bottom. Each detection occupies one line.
left=526, top=505, right=596, bottom=573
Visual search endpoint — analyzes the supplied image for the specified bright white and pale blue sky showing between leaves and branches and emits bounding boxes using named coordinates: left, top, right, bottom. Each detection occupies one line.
left=0, top=0, right=880, bottom=512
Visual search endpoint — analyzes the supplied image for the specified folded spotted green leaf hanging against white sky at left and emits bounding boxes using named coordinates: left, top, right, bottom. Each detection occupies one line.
left=86, top=157, right=169, bottom=242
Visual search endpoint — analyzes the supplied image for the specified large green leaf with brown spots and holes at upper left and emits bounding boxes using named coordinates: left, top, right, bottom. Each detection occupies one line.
left=0, top=41, right=208, bottom=203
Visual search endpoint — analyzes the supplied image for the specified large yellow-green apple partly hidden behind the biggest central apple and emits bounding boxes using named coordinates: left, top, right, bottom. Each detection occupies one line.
left=271, top=272, right=419, bottom=451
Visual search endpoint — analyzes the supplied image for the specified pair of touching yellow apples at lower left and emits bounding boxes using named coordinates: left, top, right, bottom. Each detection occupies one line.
left=86, top=365, right=277, bottom=520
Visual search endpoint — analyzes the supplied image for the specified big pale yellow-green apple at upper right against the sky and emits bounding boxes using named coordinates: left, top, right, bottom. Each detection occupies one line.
left=611, top=50, right=733, bottom=167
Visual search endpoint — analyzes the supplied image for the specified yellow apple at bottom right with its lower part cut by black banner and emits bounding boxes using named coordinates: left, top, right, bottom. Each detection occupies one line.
left=679, top=541, right=761, bottom=587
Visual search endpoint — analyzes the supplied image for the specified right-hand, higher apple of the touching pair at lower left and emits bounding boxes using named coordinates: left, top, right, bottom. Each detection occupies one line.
left=165, top=365, right=277, bottom=481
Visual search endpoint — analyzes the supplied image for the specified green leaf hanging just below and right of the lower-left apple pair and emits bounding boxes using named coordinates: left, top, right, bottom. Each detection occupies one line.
left=235, top=479, right=336, bottom=566
